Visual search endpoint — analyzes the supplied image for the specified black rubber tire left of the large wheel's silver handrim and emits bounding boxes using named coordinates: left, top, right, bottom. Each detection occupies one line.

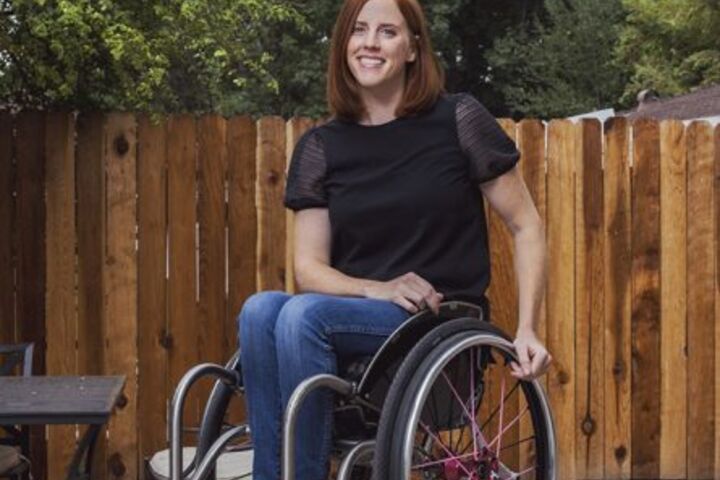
left=373, top=317, right=510, bottom=480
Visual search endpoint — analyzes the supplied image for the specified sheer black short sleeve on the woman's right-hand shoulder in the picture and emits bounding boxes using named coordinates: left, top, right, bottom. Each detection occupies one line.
left=455, top=93, right=520, bottom=183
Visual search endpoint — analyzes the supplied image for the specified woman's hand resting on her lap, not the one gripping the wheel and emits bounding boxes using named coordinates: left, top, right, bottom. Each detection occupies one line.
left=365, top=272, right=443, bottom=315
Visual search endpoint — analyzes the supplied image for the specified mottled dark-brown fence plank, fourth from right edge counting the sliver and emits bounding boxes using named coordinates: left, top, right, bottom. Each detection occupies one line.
left=632, top=120, right=660, bottom=479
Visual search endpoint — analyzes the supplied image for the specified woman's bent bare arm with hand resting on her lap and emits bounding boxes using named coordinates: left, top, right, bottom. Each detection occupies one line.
left=295, top=208, right=442, bottom=313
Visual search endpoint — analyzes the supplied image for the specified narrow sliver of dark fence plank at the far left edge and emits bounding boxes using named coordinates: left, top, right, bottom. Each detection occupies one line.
left=0, top=112, right=15, bottom=343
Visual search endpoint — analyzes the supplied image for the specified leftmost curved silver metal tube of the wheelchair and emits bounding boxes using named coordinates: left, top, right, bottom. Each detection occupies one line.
left=169, top=363, right=241, bottom=480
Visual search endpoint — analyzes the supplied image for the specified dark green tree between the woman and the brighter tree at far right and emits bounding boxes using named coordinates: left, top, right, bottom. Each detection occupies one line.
left=488, top=0, right=627, bottom=118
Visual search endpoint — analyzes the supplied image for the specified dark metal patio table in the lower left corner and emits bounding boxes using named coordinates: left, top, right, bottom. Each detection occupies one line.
left=0, top=376, right=125, bottom=480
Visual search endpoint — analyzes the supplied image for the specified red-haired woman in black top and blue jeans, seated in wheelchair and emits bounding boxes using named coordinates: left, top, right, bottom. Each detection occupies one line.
left=239, top=0, right=550, bottom=480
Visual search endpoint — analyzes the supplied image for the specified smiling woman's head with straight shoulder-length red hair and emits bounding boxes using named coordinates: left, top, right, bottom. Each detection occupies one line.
left=327, top=0, right=445, bottom=124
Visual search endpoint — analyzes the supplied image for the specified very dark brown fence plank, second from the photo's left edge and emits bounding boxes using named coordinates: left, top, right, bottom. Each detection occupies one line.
left=15, top=112, right=46, bottom=478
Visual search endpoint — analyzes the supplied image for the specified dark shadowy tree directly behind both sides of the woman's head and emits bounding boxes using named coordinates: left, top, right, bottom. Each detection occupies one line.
left=226, top=0, right=542, bottom=116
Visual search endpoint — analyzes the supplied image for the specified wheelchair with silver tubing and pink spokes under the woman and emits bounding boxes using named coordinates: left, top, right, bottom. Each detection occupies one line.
left=156, top=301, right=556, bottom=480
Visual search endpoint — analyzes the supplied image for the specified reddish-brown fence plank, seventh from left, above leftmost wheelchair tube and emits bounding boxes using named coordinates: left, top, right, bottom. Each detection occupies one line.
left=167, top=115, right=199, bottom=432
